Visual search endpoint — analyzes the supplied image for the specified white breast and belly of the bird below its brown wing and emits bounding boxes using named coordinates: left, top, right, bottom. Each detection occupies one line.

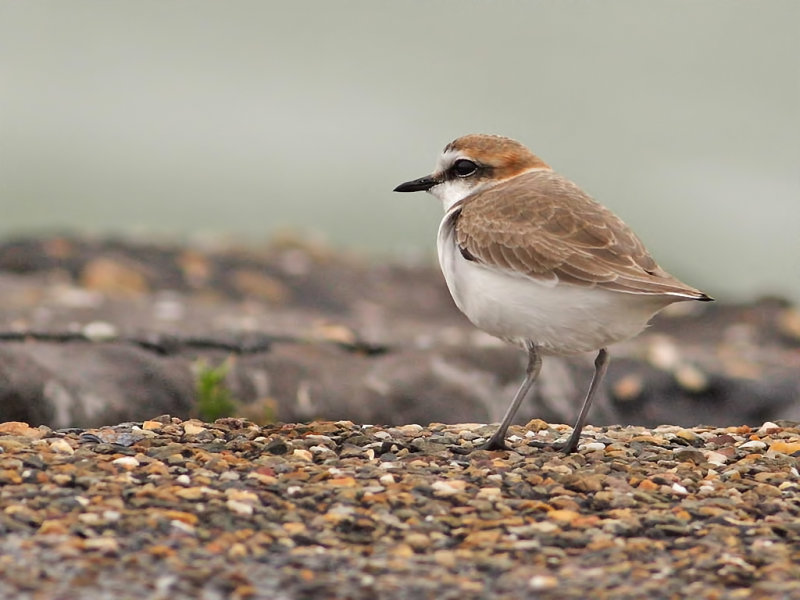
left=438, top=220, right=676, bottom=354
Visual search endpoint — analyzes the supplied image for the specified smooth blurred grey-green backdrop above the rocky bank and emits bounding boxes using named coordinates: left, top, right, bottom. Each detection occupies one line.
left=0, top=0, right=800, bottom=300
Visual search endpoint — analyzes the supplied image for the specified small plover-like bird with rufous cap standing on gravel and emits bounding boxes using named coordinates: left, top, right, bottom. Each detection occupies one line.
left=394, top=134, right=713, bottom=453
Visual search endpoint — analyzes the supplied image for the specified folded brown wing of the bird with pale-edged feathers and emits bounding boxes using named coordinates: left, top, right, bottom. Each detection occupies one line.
left=455, top=171, right=707, bottom=299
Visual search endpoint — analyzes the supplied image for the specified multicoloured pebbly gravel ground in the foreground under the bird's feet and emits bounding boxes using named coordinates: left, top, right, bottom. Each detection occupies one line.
left=0, top=416, right=800, bottom=600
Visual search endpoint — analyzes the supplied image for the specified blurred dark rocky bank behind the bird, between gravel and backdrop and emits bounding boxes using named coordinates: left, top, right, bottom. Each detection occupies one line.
left=0, top=236, right=800, bottom=428
